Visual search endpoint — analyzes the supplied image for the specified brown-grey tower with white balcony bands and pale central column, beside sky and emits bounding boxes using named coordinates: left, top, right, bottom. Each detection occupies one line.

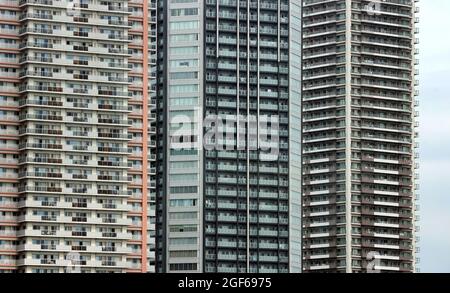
left=302, top=0, right=418, bottom=272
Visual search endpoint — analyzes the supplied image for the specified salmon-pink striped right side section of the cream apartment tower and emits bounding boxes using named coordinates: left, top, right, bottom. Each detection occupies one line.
left=128, top=0, right=157, bottom=272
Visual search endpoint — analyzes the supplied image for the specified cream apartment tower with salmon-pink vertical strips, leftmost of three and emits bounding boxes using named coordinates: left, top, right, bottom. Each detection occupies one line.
left=0, top=0, right=156, bottom=272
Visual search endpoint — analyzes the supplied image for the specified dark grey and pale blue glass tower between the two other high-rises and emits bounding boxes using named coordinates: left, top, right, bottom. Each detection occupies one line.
left=156, top=0, right=301, bottom=273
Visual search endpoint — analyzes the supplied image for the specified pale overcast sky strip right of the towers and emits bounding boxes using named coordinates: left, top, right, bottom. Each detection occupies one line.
left=419, top=0, right=450, bottom=273
